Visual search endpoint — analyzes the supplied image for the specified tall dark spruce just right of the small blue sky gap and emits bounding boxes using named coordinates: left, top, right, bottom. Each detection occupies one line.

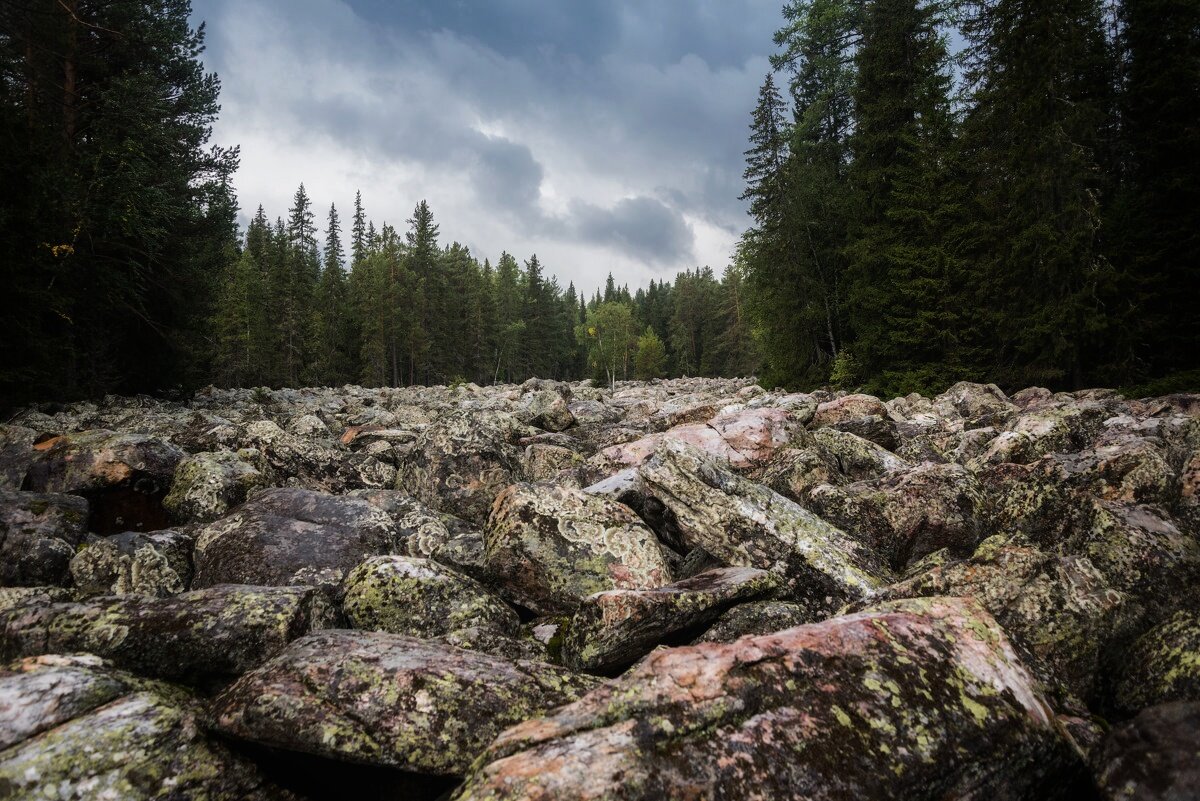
left=962, top=0, right=1110, bottom=387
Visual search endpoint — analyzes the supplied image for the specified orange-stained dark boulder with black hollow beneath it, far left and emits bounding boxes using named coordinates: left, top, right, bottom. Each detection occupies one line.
left=24, top=429, right=184, bottom=535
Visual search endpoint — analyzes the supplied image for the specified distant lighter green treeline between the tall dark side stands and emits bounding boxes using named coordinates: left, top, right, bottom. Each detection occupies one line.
left=211, top=185, right=757, bottom=386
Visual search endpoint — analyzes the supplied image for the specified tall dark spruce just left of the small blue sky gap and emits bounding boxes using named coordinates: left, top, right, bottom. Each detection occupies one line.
left=847, top=0, right=964, bottom=397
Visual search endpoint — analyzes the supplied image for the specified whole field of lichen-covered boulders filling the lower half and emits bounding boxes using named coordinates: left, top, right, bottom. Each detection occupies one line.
left=0, top=380, right=1200, bottom=801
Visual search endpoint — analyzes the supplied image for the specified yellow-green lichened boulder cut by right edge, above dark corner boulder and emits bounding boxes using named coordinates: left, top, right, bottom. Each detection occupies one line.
left=1116, top=609, right=1200, bottom=713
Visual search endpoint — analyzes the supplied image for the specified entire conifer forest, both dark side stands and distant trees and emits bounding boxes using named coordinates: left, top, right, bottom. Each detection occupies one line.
left=0, top=0, right=1200, bottom=405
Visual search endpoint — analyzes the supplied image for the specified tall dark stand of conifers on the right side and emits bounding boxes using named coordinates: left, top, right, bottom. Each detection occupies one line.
left=740, top=0, right=1200, bottom=395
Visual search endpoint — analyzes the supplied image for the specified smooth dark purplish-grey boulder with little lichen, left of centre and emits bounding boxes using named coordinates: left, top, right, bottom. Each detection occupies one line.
left=193, top=488, right=401, bottom=588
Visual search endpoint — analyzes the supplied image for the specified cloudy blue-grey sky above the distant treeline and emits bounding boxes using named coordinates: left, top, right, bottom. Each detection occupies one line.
left=193, top=0, right=781, bottom=291
